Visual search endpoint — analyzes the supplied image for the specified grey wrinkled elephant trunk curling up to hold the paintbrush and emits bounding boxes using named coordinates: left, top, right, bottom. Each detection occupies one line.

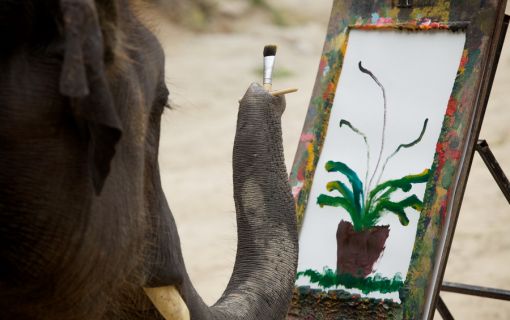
left=181, top=84, right=298, bottom=320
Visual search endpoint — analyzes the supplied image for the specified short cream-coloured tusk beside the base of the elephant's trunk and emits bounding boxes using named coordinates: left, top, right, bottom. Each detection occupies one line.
left=144, top=286, right=190, bottom=320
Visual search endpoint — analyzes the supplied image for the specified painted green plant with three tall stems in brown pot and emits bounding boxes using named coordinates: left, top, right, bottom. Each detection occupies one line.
left=317, top=61, right=430, bottom=278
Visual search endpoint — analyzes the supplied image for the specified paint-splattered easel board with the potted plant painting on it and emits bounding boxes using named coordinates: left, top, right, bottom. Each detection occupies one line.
left=289, top=0, right=506, bottom=319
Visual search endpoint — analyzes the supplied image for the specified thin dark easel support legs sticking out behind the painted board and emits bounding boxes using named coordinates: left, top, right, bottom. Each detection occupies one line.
left=436, top=15, right=510, bottom=320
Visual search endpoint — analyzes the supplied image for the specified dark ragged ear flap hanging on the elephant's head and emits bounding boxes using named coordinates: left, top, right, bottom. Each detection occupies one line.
left=60, top=0, right=122, bottom=195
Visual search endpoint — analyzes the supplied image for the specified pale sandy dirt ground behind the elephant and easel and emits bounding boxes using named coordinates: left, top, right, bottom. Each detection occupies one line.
left=145, top=0, right=510, bottom=319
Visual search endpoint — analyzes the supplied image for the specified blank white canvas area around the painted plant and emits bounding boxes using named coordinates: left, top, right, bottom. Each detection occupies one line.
left=296, top=30, right=465, bottom=301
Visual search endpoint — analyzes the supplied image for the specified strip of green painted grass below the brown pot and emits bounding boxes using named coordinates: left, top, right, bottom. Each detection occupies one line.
left=296, top=268, right=404, bottom=294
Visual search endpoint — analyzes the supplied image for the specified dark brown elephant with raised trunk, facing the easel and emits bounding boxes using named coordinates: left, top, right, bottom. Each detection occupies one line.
left=0, top=0, right=298, bottom=320
